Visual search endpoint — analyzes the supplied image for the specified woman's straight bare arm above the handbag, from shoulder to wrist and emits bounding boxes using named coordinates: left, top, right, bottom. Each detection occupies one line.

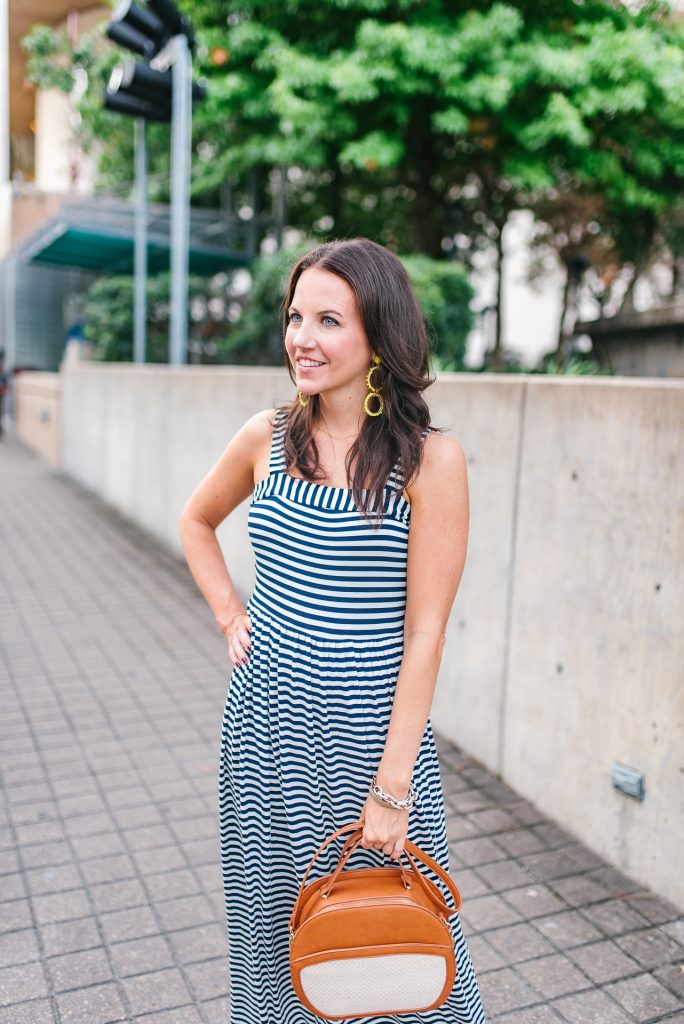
left=378, top=433, right=470, bottom=799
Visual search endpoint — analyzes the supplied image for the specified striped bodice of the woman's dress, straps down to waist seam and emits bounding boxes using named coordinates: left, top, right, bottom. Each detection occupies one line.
left=248, top=410, right=427, bottom=639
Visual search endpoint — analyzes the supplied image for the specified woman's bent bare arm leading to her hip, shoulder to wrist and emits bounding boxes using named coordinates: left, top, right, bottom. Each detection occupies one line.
left=178, top=410, right=273, bottom=640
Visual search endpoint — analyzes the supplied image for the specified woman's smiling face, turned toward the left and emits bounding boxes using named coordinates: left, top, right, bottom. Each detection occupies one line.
left=285, top=267, right=375, bottom=394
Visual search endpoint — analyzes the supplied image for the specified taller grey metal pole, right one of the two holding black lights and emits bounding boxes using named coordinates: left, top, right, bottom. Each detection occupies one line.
left=169, top=35, right=193, bottom=367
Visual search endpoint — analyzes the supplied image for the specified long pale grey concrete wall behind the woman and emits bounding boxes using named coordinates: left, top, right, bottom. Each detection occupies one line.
left=52, top=364, right=684, bottom=907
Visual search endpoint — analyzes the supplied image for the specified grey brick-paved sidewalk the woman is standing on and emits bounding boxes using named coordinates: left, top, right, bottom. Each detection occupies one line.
left=0, top=435, right=684, bottom=1024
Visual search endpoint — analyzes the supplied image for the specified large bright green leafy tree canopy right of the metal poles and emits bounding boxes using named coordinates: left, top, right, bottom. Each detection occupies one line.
left=21, top=0, right=684, bottom=369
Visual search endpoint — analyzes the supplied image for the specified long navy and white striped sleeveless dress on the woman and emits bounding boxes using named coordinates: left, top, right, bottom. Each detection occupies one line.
left=219, top=409, right=485, bottom=1024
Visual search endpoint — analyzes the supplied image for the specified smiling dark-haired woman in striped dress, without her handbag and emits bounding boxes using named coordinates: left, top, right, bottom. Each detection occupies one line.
left=180, top=239, right=484, bottom=1024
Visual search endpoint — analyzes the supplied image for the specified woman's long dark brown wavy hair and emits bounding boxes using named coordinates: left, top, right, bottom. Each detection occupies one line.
left=281, top=238, right=441, bottom=525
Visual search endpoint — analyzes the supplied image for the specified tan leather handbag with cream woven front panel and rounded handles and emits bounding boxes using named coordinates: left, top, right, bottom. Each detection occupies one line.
left=290, top=821, right=462, bottom=1020
